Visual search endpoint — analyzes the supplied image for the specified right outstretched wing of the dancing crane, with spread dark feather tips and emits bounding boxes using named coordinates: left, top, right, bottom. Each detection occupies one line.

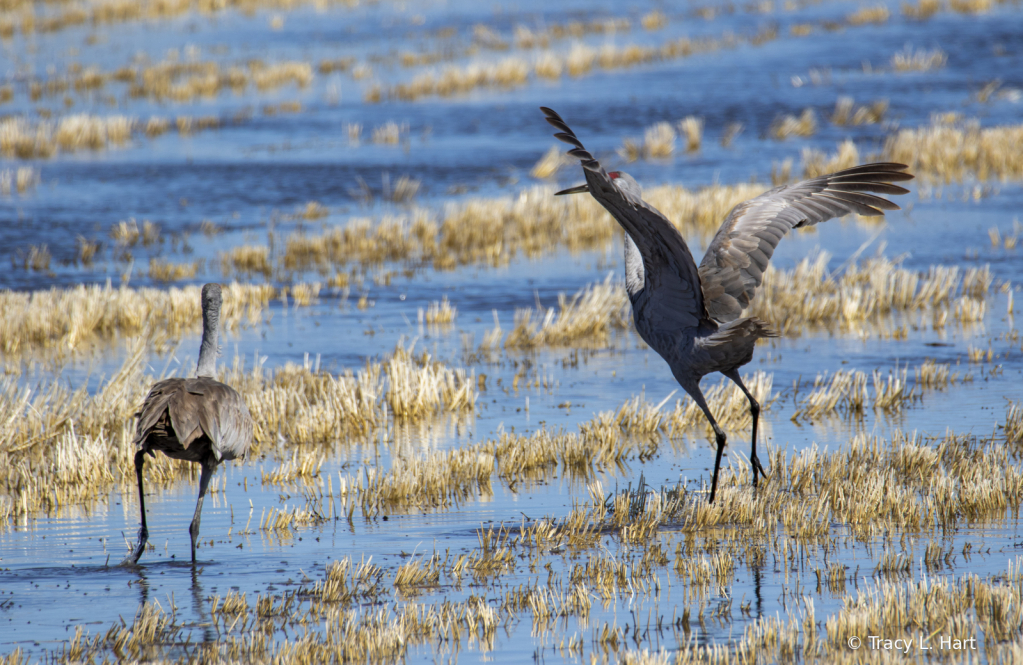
left=700, top=162, right=913, bottom=322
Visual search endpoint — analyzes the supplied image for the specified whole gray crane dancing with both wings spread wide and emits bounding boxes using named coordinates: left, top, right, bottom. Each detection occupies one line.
left=540, top=106, right=913, bottom=502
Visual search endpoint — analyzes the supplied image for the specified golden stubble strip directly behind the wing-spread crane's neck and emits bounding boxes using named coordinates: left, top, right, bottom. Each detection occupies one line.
left=270, top=184, right=766, bottom=273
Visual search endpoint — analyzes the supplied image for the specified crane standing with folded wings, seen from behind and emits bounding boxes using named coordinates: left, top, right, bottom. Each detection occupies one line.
left=123, top=284, right=253, bottom=564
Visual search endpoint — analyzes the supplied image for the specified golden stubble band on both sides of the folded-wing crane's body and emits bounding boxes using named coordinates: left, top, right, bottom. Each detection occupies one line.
left=0, top=341, right=477, bottom=528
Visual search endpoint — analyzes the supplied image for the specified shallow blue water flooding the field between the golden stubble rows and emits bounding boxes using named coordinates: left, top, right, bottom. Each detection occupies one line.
left=0, top=2, right=1023, bottom=662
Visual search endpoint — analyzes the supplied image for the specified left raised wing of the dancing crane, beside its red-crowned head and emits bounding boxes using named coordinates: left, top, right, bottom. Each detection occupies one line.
left=540, top=106, right=707, bottom=331
